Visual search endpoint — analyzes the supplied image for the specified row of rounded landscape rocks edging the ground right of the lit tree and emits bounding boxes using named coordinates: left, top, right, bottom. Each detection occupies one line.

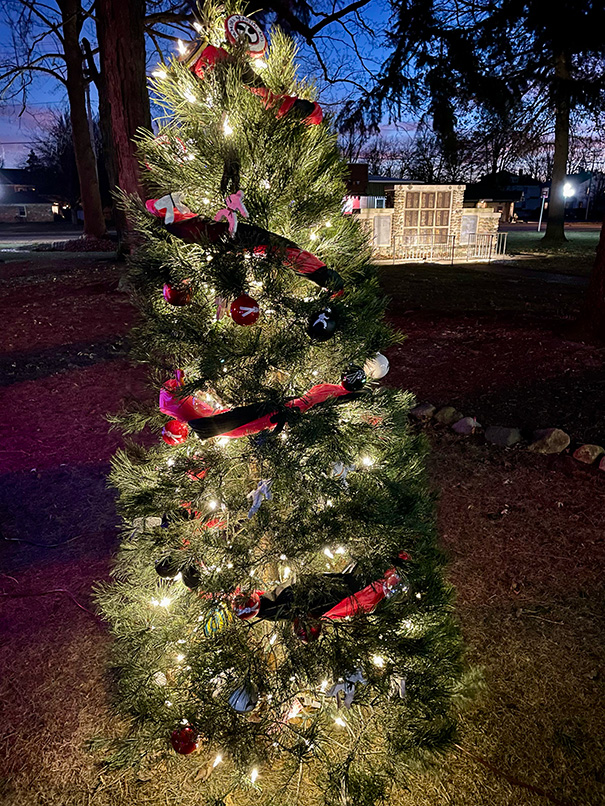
left=410, top=401, right=605, bottom=471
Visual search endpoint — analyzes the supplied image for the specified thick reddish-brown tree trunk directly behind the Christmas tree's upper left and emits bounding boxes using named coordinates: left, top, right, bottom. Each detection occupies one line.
left=97, top=0, right=151, bottom=228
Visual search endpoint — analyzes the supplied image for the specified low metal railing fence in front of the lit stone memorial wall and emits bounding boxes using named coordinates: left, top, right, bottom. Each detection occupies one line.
left=374, top=232, right=508, bottom=263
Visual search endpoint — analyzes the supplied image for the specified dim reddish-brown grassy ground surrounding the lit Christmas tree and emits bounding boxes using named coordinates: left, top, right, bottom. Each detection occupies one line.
left=0, top=254, right=605, bottom=806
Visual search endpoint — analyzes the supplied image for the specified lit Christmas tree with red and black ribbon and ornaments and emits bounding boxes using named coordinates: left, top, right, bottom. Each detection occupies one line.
left=99, top=3, right=463, bottom=806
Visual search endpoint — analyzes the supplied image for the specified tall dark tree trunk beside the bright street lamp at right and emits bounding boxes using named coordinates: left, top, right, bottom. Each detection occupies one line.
left=543, top=53, right=570, bottom=246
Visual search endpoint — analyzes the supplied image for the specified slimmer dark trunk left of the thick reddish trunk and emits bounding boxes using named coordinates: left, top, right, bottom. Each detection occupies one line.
left=58, top=0, right=107, bottom=238
